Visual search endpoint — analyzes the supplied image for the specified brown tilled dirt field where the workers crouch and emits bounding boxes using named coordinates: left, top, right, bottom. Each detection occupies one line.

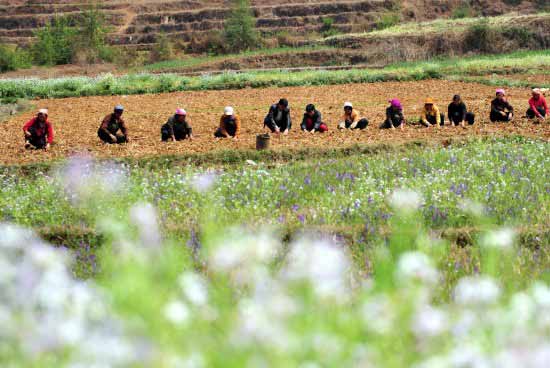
left=0, top=80, right=550, bottom=164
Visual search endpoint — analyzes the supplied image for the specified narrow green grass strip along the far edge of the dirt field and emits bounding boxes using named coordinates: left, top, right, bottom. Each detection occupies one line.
left=0, top=50, right=550, bottom=99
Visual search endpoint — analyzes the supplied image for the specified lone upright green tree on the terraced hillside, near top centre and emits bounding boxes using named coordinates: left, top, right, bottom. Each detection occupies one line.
left=224, top=0, right=260, bottom=51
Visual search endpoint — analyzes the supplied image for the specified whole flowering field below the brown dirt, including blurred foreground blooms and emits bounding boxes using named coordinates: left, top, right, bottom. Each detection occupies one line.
left=0, top=138, right=550, bottom=368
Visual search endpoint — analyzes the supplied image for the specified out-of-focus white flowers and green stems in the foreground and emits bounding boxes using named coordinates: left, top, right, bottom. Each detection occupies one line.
left=0, top=162, right=550, bottom=368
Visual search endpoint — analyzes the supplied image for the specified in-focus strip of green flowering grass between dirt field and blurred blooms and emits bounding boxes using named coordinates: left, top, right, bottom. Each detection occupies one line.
left=0, top=137, right=550, bottom=246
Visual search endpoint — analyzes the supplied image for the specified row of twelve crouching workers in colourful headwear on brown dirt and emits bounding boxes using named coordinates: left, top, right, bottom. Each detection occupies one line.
left=23, top=88, right=548, bottom=149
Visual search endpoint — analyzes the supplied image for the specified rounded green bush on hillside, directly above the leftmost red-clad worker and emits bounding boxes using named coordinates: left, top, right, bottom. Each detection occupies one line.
left=32, top=17, right=77, bottom=65
